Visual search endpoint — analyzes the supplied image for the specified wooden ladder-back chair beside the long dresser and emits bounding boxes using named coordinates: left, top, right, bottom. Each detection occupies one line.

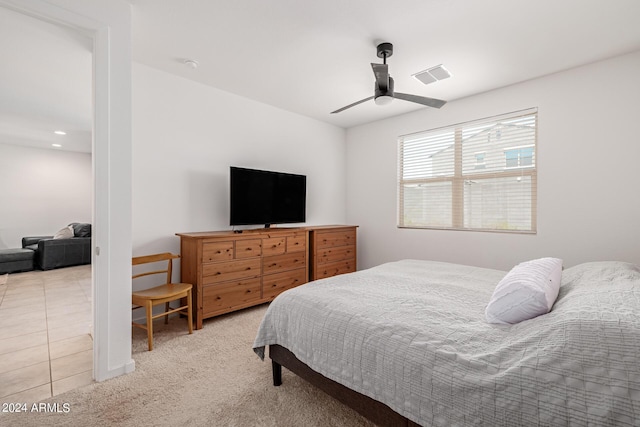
left=131, top=252, right=193, bottom=351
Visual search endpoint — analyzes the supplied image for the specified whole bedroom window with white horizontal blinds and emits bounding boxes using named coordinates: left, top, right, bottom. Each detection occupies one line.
left=398, top=109, right=537, bottom=233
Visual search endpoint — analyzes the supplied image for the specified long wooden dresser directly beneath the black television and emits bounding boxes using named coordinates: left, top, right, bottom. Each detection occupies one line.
left=177, top=228, right=309, bottom=329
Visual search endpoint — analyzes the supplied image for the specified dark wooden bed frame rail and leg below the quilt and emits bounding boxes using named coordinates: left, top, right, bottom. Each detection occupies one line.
left=269, top=345, right=419, bottom=427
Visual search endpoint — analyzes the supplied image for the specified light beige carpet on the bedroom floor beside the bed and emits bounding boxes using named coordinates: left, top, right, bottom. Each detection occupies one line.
left=0, top=305, right=373, bottom=427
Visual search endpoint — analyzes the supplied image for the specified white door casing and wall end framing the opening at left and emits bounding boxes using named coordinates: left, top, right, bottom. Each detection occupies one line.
left=0, top=0, right=135, bottom=392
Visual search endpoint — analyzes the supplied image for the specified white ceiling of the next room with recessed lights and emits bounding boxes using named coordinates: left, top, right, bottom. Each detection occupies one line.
left=0, top=7, right=92, bottom=152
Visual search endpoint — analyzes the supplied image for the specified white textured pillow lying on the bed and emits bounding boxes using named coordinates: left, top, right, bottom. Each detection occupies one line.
left=485, top=258, right=562, bottom=324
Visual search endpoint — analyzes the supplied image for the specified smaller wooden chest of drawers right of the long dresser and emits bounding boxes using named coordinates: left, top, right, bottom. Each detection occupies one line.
left=307, top=225, right=357, bottom=280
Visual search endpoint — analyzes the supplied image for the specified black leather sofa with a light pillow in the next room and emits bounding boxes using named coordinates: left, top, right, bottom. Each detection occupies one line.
left=22, top=222, right=91, bottom=270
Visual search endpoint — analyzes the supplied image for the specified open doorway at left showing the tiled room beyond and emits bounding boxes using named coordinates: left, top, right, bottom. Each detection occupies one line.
left=0, top=7, right=94, bottom=402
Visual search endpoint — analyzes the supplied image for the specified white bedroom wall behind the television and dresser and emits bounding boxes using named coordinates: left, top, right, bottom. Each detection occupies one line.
left=133, top=63, right=346, bottom=260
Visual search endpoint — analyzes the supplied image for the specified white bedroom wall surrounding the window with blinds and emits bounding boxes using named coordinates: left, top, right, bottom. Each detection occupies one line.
left=347, top=52, right=640, bottom=270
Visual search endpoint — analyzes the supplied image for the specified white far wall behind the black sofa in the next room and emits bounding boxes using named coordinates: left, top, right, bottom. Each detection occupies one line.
left=0, top=143, right=93, bottom=249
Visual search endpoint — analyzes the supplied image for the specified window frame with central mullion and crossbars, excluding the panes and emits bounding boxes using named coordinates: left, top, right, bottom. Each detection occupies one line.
left=396, top=108, right=538, bottom=234
